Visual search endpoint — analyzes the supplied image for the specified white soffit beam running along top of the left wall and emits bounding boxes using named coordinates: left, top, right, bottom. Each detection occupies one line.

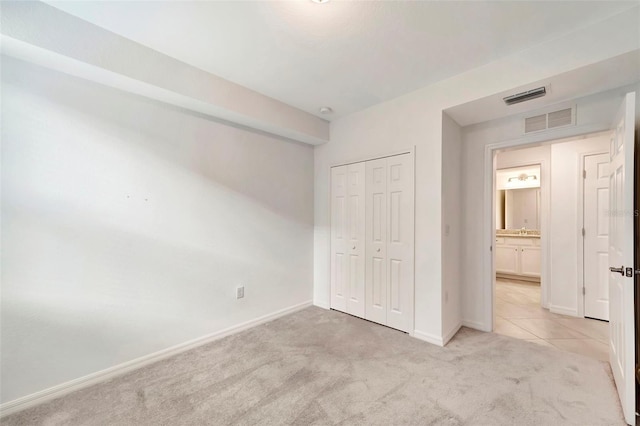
left=0, top=2, right=329, bottom=145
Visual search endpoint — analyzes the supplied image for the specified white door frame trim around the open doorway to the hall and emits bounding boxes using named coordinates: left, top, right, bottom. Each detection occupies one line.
left=481, top=123, right=610, bottom=331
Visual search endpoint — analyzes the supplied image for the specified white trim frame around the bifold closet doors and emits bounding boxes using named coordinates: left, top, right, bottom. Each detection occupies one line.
left=326, top=145, right=416, bottom=337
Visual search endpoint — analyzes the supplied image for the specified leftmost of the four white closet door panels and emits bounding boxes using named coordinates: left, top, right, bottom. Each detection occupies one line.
left=331, top=166, right=349, bottom=312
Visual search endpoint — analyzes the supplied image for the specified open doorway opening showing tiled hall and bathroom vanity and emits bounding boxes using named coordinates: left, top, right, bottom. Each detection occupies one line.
left=489, top=132, right=609, bottom=361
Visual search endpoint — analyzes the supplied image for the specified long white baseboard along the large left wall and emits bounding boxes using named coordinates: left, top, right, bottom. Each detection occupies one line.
left=0, top=301, right=312, bottom=417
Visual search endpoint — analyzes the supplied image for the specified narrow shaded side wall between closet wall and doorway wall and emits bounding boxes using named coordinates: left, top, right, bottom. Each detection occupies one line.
left=441, top=113, right=462, bottom=344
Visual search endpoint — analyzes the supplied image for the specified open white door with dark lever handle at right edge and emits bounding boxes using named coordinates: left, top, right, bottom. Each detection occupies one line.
left=609, top=92, right=636, bottom=425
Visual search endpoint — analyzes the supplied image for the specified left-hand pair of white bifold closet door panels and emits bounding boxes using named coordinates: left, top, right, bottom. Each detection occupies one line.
left=331, top=163, right=365, bottom=318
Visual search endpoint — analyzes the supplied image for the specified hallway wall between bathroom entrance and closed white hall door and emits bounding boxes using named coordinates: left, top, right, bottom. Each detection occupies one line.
left=549, top=132, right=609, bottom=316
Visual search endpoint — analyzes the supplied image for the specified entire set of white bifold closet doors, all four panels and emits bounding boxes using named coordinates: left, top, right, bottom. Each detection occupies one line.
left=331, top=154, right=414, bottom=332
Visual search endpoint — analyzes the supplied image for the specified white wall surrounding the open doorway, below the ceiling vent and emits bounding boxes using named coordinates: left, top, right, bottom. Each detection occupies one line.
left=462, top=85, right=640, bottom=330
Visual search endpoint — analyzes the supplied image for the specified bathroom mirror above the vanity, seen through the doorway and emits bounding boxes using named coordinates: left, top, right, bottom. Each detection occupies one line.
left=496, top=188, right=540, bottom=230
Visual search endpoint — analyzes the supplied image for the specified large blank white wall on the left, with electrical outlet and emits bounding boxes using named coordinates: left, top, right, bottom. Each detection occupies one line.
left=1, top=57, right=313, bottom=401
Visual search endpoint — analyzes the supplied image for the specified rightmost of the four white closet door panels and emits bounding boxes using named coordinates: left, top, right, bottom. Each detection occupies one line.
left=387, top=154, right=414, bottom=332
